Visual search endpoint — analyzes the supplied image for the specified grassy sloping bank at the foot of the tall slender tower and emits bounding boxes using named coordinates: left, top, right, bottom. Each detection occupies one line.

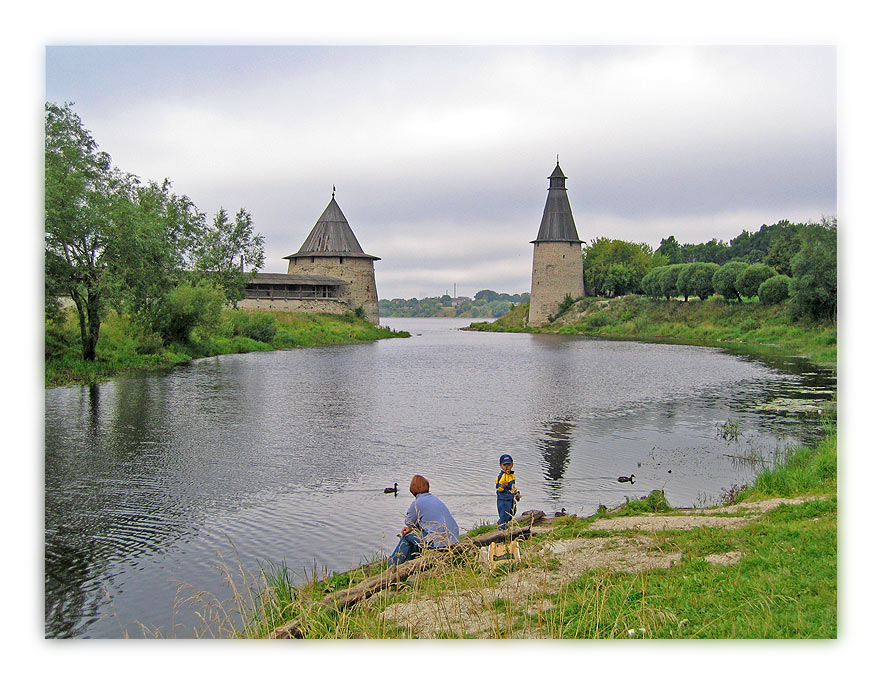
left=471, top=295, right=837, bottom=365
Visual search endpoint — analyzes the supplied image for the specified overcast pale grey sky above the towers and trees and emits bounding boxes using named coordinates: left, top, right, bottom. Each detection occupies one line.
left=46, top=46, right=837, bottom=298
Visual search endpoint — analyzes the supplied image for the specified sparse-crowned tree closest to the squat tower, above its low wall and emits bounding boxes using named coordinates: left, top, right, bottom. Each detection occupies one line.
left=195, top=207, right=264, bottom=306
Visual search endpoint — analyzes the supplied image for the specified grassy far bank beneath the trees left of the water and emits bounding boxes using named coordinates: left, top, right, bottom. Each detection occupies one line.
left=45, top=311, right=410, bottom=387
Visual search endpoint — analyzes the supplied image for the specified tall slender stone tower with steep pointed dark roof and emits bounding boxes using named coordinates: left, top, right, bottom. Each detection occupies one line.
left=528, top=164, right=585, bottom=327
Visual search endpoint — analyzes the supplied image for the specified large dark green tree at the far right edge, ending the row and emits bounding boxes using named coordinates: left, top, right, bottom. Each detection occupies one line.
left=790, top=217, right=837, bottom=321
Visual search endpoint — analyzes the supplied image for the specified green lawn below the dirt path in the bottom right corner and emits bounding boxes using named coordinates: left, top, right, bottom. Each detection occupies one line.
left=550, top=499, right=837, bottom=639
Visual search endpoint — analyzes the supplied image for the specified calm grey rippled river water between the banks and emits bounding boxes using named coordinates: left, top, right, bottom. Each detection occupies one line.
left=45, top=319, right=836, bottom=637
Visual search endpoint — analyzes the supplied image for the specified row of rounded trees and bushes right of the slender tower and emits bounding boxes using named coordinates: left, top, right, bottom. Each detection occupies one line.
left=583, top=217, right=837, bottom=321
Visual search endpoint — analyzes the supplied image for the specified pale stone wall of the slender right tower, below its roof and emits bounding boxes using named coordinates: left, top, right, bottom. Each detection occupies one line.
left=527, top=242, right=585, bottom=327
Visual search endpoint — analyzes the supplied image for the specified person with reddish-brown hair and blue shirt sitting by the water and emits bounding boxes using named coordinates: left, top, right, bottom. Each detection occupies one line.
left=389, top=475, right=459, bottom=566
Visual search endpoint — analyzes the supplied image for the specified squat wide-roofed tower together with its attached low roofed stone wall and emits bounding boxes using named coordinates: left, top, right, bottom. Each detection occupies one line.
left=239, top=193, right=380, bottom=325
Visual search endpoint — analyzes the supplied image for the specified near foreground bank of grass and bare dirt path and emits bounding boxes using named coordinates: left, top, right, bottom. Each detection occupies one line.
left=201, top=430, right=837, bottom=639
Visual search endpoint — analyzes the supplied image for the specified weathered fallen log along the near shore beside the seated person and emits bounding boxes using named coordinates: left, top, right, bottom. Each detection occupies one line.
left=269, top=511, right=545, bottom=639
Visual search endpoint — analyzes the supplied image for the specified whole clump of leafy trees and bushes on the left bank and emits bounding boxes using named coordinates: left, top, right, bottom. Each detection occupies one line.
left=45, top=102, right=264, bottom=360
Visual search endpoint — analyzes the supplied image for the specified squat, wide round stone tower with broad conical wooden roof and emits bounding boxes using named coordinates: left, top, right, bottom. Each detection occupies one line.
left=285, top=193, right=380, bottom=325
